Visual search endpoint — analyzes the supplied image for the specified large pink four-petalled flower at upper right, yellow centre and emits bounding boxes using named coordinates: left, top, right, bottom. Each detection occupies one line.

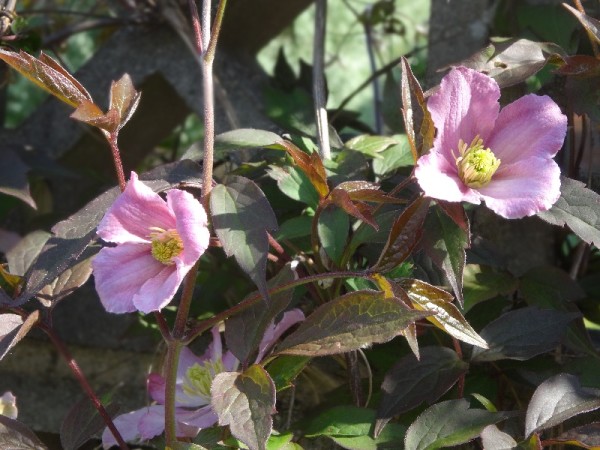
left=415, top=67, right=567, bottom=219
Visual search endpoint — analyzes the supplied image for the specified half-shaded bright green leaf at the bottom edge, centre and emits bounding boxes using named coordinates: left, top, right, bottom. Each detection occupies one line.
left=306, top=405, right=406, bottom=450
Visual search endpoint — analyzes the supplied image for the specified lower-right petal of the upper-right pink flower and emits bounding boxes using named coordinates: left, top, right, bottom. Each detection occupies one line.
left=480, top=157, right=560, bottom=219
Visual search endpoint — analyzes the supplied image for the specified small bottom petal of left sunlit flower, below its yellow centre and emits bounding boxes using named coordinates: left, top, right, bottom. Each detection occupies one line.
left=133, top=264, right=183, bottom=314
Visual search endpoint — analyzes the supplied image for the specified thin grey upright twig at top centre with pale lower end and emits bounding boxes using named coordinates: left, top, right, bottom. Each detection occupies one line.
left=313, top=0, right=331, bottom=160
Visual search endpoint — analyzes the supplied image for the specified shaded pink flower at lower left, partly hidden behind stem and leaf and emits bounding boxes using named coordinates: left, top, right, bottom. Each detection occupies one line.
left=102, top=309, right=304, bottom=449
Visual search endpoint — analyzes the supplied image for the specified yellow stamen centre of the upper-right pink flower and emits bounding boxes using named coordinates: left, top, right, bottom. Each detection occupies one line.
left=455, top=136, right=500, bottom=188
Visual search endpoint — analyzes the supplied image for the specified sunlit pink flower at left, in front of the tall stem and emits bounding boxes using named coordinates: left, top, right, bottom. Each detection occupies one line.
left=92, top=172, right=209, bottom=313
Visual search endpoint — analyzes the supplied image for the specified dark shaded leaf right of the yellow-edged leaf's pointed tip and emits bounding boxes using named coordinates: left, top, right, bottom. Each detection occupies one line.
left=471, top=307, right=579, bottom=362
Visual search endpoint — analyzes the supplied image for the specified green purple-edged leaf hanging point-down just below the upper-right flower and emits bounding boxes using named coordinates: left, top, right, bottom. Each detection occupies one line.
left=423, top=208, right=470, bottom=305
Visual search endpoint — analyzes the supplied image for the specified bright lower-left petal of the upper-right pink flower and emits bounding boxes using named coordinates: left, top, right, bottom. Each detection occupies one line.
left=415, top=151, right=481, bottom=204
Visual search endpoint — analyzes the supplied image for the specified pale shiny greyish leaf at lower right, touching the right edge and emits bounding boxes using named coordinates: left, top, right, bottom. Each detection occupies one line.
left=525, top=373, right=600, bottom=437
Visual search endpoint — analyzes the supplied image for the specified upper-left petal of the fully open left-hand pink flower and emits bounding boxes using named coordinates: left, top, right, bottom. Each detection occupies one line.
left=98, top=172, right=175, bottom=244
